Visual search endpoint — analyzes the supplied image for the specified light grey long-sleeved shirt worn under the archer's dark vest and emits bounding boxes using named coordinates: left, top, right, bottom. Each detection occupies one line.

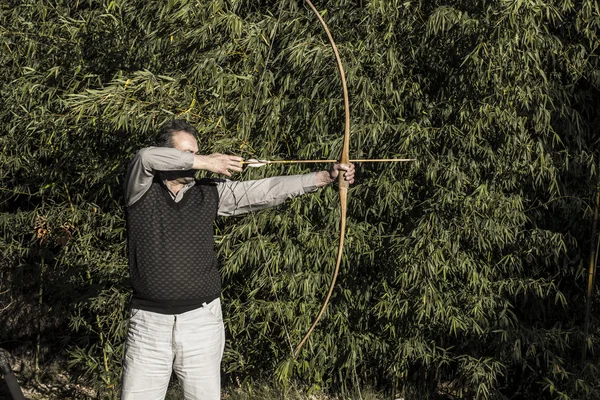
left=125, top=147, right=317, bottom=216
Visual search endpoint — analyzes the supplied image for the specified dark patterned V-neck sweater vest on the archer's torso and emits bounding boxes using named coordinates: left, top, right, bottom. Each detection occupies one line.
left=127, top=180, right=221, bottom=314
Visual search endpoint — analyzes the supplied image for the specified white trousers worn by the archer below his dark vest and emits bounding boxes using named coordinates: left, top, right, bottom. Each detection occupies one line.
left=121, top=299, right=225, bottom=400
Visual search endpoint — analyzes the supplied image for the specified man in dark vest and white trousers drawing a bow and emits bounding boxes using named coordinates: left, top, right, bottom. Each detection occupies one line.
left=121, top=120, right=354, bottom=400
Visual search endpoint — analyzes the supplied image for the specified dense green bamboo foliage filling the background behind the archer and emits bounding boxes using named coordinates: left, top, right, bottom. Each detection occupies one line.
left=0, top=0, right=600, bottom=399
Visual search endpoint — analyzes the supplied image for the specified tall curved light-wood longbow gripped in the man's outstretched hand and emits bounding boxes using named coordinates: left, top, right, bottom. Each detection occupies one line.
left=293, top=0, right=350, bottom=358
